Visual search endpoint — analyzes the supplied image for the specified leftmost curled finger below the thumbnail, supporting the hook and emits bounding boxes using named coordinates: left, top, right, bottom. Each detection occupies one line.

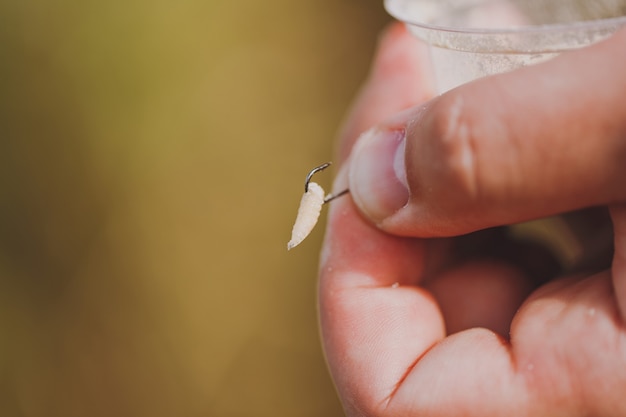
left=319, top=192, right=445, bottom=416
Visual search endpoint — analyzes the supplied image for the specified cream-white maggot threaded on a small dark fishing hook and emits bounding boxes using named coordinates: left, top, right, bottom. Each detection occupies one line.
left=287, top=162, right=349, bottom=250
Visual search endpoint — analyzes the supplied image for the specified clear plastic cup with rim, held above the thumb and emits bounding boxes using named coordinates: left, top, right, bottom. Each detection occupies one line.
left=385, top=0, right=626, bottom=92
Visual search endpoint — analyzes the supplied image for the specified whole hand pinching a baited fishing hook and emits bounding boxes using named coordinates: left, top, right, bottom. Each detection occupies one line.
left=319, top=26, right=626, bottom=417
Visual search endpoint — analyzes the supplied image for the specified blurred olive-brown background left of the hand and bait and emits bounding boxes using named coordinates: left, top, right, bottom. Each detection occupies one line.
left=0, top=0, right=390, bottom=417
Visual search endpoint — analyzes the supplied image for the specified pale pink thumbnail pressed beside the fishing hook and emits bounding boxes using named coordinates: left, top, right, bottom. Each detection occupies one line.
left=349, top=129, right=409, bottom=223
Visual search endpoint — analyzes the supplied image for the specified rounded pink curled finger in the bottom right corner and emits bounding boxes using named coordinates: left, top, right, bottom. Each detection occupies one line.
left=511, top=271, right=626, bottom=416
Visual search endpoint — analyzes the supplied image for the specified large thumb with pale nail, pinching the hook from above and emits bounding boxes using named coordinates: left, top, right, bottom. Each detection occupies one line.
left=349, top=31, right=626, bottom=237
